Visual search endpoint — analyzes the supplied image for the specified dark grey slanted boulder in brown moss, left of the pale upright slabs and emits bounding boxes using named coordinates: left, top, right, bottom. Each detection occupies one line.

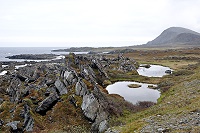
left=36, top=93, right=59, bottom=115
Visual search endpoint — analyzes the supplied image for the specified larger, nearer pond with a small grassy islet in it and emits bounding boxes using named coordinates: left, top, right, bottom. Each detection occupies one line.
left=106, top=82, right=160, bottom=104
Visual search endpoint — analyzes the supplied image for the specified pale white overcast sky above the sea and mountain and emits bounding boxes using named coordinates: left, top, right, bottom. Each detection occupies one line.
left=0, top=0, right=200, bottom=47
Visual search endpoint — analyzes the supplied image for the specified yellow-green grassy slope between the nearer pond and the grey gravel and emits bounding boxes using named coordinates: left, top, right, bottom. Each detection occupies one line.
left=111, top=64, right=200, bottom=133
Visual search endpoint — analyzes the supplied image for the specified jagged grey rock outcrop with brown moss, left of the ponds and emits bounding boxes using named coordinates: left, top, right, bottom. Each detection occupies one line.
left=0, top=54, right=139, bottom=133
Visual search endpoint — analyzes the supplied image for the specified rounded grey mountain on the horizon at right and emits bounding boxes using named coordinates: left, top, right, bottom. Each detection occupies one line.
left=146, top=27, right=200, bottom=46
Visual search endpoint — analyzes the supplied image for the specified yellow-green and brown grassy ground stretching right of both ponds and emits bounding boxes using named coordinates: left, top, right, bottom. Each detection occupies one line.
left=108, top=48, right=200, bottom=133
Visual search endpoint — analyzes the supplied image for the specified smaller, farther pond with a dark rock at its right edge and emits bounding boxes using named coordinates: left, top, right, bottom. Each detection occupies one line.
left=137, top=65, right=171, bottom=77
